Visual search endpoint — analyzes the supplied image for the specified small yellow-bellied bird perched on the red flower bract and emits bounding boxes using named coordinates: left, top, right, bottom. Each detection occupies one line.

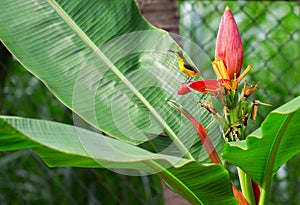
left=168, top=50, right=204, bottom=82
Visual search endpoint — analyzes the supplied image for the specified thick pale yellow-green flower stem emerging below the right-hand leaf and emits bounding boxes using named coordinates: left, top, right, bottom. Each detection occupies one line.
left=237, top=167, right=256, bottom=205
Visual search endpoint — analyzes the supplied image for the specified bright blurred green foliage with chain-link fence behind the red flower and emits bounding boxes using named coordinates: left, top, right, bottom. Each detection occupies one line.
left=178, top=0, right=300, bottom=205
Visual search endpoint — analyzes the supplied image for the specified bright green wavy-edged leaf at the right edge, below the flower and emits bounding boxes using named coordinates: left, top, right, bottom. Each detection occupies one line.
left=223, top=97, right=300, bottom=186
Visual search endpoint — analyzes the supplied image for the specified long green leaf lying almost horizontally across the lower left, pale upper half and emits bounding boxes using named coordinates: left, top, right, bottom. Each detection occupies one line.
left=0, top=116, right=236, bottom=204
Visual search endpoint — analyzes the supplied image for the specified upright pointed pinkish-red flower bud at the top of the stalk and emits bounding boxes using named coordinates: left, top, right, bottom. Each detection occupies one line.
left=215, top=7, right=244, bottom=80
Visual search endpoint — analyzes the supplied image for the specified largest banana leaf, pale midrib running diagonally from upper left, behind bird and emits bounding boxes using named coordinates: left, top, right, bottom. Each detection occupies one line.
left=0, top=0, right=221, bottom=159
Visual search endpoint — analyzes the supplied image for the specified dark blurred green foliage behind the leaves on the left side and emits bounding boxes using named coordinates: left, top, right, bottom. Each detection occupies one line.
left=0, top=44, right=163, bottom=205
